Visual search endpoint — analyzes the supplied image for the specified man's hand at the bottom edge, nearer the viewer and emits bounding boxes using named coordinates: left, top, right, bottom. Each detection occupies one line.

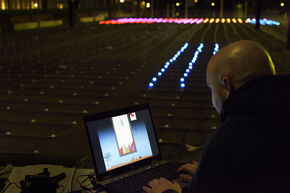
left=143, top=178, right=182, bottom=193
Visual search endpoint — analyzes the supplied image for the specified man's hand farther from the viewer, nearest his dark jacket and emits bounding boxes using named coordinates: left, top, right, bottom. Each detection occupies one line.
left=177, top=161, right=198, bottom=182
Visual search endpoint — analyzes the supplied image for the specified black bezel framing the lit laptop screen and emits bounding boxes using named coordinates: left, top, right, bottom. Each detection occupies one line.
left=83, top=103, right=161, bottom=181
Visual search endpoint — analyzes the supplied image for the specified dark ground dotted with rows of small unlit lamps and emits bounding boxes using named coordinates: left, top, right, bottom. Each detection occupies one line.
left=0, top=20, right=290, bottom=167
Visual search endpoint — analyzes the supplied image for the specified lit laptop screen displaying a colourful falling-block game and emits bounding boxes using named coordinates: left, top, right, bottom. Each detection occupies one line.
left=87, top=109, right=159, bottom=174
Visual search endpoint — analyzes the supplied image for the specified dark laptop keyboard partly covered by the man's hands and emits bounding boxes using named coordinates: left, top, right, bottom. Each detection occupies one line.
left=106, top=163, right=181, bottom=193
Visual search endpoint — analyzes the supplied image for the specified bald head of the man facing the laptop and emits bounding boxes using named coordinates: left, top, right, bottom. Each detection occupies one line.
left=206, top=40, right=276, bottom=113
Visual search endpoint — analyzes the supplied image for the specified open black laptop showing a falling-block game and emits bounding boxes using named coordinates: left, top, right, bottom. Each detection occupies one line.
left=83, top=104, right=186, bottom=193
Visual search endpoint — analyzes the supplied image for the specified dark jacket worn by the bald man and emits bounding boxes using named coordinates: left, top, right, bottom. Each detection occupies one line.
left=164, top=76, right=290, bottom=193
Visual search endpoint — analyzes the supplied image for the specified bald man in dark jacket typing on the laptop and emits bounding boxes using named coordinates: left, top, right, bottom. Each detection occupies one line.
left=143, top=40, right=290, bottom=193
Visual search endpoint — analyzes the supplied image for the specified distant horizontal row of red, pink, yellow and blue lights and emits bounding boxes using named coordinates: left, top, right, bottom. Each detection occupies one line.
left=99, top=18, right=280, bottom=25
